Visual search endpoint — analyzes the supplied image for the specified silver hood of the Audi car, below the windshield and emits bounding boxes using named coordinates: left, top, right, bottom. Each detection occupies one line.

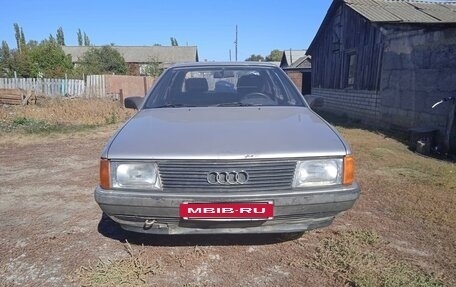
left=103, top=107, right=348, bottom=159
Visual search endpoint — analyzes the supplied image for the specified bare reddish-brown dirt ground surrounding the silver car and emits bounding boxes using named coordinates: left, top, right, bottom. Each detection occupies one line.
left=0, top=125, right=456, bottom=286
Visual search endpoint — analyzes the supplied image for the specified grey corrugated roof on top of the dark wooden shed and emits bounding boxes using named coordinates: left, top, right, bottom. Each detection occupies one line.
left=344, top=0, right=456, bottom=23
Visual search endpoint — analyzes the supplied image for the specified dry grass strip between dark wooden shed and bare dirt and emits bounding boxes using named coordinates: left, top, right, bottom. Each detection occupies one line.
left=339, top=128, right=456, bottom=229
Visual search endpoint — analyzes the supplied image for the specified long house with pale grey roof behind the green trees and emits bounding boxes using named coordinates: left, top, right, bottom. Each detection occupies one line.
left=62, top=46, right=198, bottom=75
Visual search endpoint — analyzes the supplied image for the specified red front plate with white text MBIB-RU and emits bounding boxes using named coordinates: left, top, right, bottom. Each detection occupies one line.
left=179, top=201, right=274, bottom=220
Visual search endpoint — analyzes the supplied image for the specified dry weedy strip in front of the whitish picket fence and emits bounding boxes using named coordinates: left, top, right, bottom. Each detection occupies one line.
left=0, top=99, right=133, bottom=133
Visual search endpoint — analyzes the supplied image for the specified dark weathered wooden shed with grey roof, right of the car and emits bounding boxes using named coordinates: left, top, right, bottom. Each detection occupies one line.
left=307, top=0, right=456, bottom=153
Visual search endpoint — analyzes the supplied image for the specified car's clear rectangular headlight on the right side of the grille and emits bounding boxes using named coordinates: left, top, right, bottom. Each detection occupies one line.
left=293, top=159, right=343, bottom=187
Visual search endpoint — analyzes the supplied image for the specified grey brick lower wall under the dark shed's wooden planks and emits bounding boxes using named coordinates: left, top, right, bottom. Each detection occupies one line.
left=312, top=88, right=381, bottom=125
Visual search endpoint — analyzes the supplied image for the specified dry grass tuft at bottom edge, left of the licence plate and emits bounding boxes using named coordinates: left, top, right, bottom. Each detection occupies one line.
left=76, top=242, right=160, bottom=286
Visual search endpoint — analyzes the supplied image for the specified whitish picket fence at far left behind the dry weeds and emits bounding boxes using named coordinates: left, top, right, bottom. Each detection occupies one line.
left=0, top=75, right=106, bottom=97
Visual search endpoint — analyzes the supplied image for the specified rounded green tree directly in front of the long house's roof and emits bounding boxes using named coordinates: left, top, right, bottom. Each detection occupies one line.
left=79, top=46, right=127, bottom=75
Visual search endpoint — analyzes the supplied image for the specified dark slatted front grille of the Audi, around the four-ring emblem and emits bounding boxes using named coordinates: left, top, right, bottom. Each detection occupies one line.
left=158, top=160, right=296, bottom=192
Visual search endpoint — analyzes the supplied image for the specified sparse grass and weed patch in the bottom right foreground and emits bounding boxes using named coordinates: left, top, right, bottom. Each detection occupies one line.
left=306, top=230, right=443, bottom=287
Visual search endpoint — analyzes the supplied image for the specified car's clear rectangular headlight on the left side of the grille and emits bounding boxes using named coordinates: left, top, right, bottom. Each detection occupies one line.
left=111, top=162, right=162, bottom=190
